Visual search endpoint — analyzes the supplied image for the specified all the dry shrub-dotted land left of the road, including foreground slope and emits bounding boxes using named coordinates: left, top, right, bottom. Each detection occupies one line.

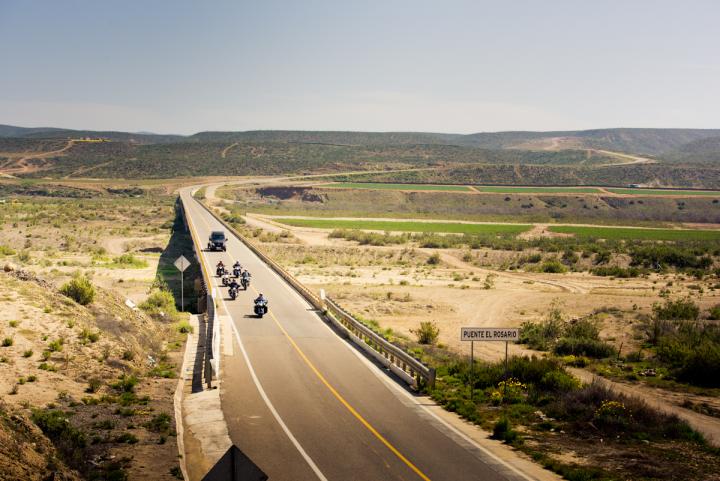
left=0, top=181, right=194, bottom=480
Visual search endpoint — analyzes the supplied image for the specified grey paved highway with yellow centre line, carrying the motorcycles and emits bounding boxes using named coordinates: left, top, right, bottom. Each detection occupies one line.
left=181, top=189, right=530, bottom=481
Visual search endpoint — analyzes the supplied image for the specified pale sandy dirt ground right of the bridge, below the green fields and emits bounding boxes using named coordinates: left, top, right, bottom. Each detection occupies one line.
left=246, top=215, right=720, bottom=444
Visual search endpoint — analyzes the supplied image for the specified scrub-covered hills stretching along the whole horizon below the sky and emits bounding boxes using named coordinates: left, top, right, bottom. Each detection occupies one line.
left=0, top=125, right=720, bottom=182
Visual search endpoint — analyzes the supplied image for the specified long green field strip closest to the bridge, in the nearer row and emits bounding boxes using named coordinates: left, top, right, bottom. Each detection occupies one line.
left=273, top=217, right=531, bottom=235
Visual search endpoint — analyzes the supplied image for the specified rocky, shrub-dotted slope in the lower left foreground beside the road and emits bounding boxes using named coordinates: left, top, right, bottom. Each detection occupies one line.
left=0, top=265, right=183, bottom=480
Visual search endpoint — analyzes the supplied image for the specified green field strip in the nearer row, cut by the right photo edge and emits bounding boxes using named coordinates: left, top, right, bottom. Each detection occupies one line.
left=549, top=226, right=720, bottom=241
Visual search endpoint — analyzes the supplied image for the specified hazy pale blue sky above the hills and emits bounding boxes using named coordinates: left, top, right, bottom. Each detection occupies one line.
left=0, top=0, right=720, bottom=133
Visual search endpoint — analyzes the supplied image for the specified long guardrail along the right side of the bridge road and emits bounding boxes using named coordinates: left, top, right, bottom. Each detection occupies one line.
left=198, top=201, right=435, bottom=389
